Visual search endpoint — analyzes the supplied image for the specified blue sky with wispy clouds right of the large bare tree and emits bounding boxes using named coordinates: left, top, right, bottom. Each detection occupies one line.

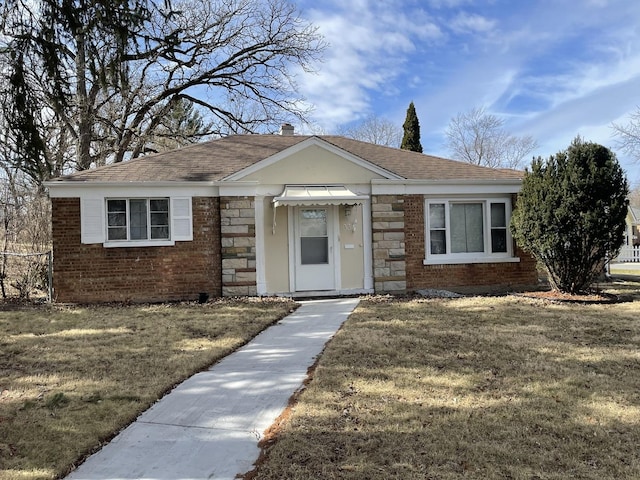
left=293, top=0, right=640, bottom=186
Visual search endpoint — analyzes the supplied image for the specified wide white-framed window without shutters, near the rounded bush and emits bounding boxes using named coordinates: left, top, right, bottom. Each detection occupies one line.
left=425, top=199, right=517, bottom=263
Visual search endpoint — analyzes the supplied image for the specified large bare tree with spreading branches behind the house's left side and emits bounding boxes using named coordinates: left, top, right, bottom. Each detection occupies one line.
left=0, top=0, right=324, bottom=181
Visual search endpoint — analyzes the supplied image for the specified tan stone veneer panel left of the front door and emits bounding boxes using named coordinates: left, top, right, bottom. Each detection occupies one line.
left=220, top=197, right=257, bottom=297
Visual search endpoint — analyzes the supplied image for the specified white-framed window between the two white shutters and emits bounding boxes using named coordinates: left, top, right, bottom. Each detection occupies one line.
left=107, top=198, right=169, bottom=241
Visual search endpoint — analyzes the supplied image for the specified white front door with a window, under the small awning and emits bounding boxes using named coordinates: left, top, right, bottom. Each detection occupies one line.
left=294, top=206, right=336, bottom=292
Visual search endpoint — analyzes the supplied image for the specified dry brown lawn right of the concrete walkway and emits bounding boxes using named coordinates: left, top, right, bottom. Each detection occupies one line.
left=253, top=284, right=640, bottom=480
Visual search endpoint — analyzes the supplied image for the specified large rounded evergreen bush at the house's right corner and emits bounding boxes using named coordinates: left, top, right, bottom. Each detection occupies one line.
left=511, top=137, right=629, bottom=294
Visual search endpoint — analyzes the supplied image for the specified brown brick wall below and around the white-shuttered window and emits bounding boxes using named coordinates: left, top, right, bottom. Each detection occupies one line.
left=51, top=197, right=221, bottom=303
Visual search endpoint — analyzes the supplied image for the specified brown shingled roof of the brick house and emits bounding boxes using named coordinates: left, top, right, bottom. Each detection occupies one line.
left=48, top=135, right=522, bottom=183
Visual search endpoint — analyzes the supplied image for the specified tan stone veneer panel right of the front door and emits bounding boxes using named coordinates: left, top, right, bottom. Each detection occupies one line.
left=371, top=195, right=407, bottom=293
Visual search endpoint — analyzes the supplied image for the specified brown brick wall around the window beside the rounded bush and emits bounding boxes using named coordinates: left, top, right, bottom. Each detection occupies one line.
left=404, top=195, right=538, bottom=291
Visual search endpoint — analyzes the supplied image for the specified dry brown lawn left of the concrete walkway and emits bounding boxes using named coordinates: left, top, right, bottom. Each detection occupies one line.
left=0, top=300, right=294, bottom=479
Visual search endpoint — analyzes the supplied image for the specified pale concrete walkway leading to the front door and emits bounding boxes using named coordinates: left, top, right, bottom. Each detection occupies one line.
left=67, top=298, right=358, bottom=480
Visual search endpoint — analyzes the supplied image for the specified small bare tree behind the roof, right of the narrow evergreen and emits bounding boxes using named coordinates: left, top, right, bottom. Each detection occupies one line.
left=445, top=107, right=538, bottom=168
